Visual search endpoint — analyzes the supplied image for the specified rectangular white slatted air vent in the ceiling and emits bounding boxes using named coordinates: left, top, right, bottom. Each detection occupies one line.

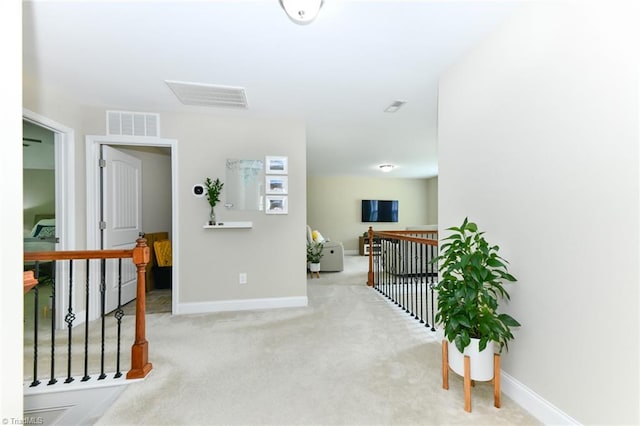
left=165, top=80, right=248, bottom=108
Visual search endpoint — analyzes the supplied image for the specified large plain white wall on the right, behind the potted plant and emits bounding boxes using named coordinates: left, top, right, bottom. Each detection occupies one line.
left=439, top=1, right=640, bottom=424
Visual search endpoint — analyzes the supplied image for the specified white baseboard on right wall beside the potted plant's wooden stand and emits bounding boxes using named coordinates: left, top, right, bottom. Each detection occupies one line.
left=500, top=371, right=580, bottom=425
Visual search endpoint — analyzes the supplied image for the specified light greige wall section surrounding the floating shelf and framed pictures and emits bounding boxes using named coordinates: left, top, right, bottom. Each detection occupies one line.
left=161, top=113, right=307, bottom=309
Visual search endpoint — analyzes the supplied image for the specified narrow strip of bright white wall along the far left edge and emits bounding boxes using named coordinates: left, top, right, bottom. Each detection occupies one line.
left=0, top=1, right=23, bottom=419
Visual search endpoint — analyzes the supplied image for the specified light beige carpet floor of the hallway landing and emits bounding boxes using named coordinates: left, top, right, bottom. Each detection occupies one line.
left=96, top=256, right=540, bottom=425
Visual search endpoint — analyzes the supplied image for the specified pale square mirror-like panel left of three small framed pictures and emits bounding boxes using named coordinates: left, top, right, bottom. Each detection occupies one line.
left=224, top=159, right=264, bottom=210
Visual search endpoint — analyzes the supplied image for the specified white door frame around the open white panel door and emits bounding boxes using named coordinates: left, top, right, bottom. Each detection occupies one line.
left=85, top=135, right=180, bottom=319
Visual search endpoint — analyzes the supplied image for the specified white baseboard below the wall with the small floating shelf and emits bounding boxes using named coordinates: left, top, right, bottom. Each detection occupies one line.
left=174, top=296, right=309, bottom=315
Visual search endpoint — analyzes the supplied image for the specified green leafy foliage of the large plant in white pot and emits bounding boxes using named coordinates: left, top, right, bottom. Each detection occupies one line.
left=432, top=218, right=520, bottom=352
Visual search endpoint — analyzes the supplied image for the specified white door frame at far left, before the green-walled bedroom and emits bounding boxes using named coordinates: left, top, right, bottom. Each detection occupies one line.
left=22, top=108, right=74, bottom=328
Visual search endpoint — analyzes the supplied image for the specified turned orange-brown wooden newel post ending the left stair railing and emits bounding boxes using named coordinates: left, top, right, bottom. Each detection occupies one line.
left=127, top=238, right=152, bottom=379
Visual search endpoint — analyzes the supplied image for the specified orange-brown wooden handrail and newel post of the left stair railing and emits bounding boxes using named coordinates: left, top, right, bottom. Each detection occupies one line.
left=24, top=238, right=152, bottom=379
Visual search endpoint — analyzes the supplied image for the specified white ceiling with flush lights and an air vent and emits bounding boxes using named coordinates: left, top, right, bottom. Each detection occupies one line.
left=23, top=0, right=518, bottom=177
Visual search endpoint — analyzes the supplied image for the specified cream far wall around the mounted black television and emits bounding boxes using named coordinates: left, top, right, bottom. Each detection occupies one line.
left=307, top=176, right=438, bottom=250
